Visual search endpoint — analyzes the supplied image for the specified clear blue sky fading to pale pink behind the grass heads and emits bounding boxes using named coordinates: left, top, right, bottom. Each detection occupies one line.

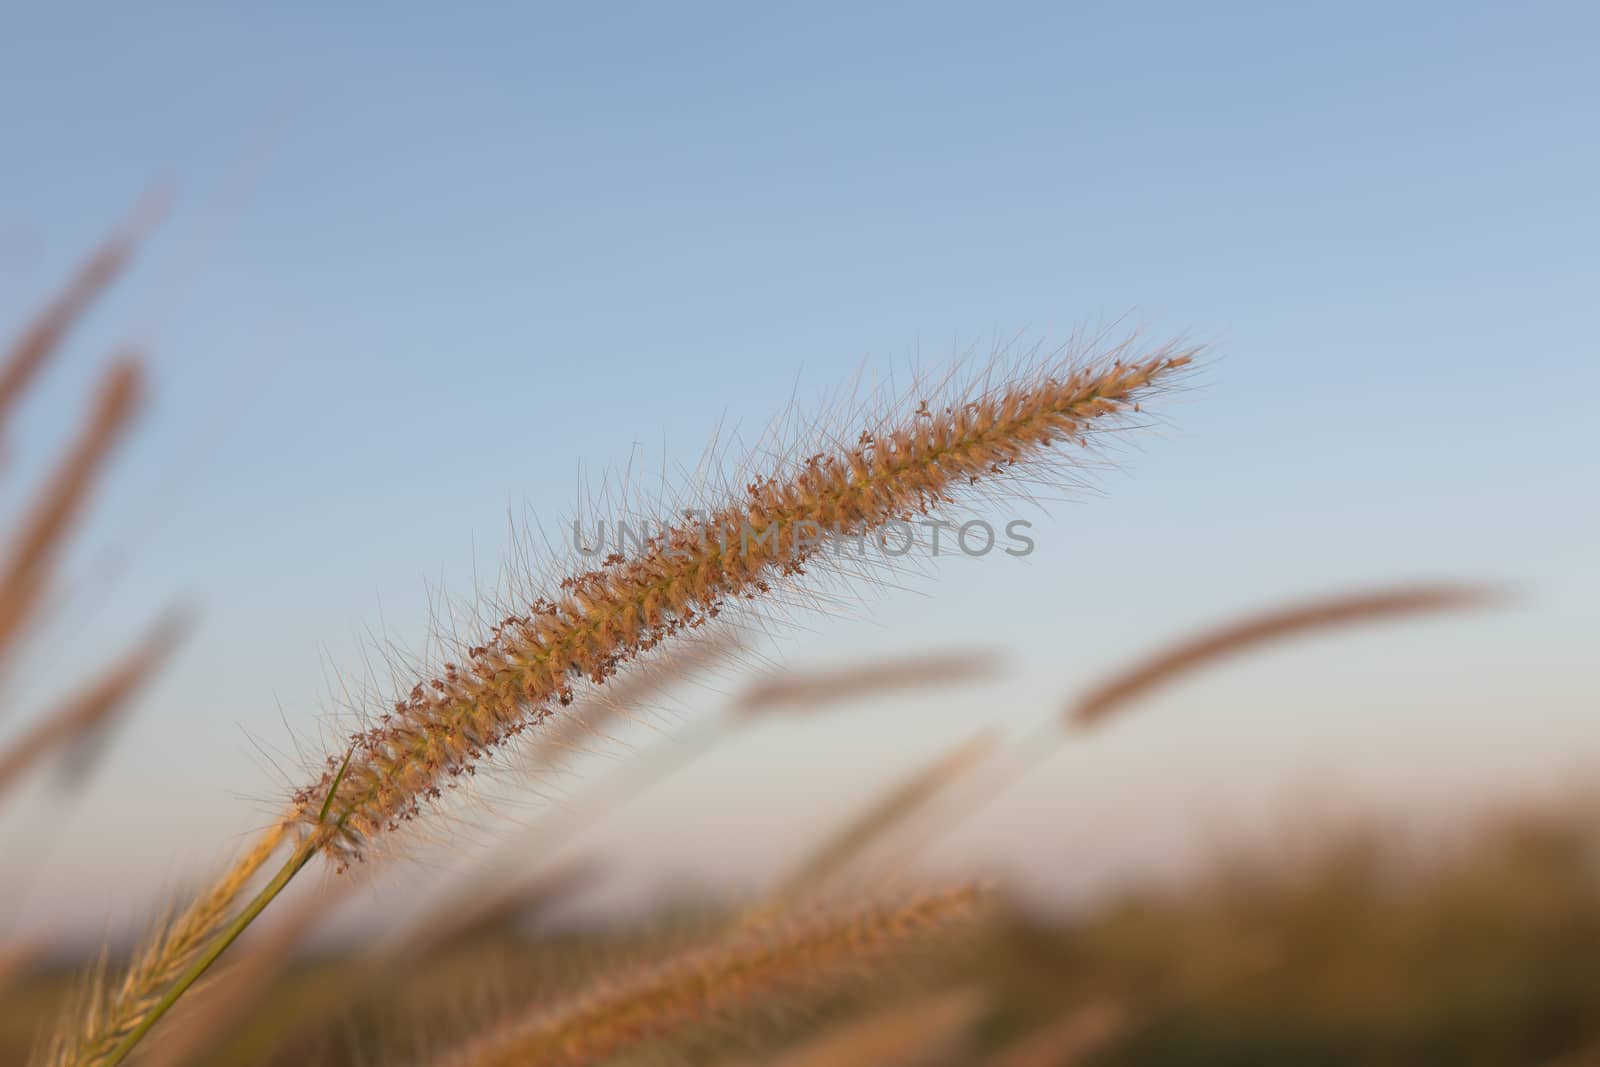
left=0, top=3, right=1600, bottom=915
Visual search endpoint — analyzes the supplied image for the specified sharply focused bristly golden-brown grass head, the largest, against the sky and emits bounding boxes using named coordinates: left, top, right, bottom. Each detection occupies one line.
left=294, top=346, right=1194, bottom=861
